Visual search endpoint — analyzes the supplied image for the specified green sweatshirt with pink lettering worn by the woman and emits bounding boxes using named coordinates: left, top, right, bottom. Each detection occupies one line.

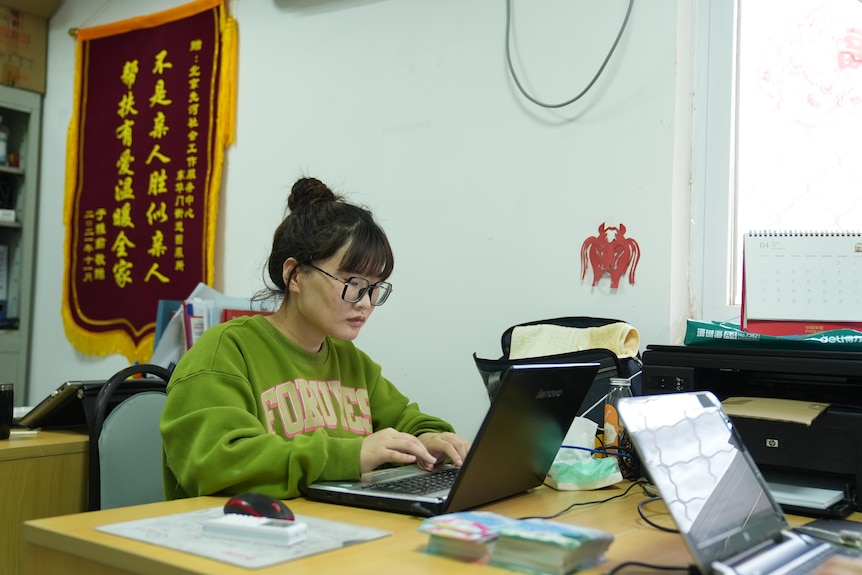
left=159, top=315, right=460, bottom=499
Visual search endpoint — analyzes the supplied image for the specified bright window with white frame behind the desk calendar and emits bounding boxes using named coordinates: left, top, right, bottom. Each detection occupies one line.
left=692, top=0, right=862, bottom=321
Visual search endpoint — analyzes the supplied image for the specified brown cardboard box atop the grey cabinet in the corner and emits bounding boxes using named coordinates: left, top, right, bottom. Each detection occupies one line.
left=0, top=0, right=61, bottom=94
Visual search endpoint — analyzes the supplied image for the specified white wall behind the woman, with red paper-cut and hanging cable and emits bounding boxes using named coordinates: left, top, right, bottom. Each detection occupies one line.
left=29, top=0, right=691, bottom=436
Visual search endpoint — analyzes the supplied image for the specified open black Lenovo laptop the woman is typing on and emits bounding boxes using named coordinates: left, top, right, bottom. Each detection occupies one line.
left=306, top=363, right=599, bottom=517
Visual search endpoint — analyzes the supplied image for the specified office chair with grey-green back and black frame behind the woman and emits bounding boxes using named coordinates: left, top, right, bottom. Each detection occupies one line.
left=88, top=364, right=171, bottom=511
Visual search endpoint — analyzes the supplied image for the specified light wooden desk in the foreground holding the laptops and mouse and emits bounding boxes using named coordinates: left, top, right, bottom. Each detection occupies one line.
left=24, top=486, right=690, bottom=575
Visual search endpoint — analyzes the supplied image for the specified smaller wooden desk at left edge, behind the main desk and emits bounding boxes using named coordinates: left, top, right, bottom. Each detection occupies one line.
left=0, top=429, right=89, bottom=575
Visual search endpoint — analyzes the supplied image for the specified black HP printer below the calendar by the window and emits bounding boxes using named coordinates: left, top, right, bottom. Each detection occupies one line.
left=642, top=345, right=862, bottom=517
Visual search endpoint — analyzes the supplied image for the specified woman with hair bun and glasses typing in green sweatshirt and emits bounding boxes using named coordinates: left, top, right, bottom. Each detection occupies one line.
left=160, top=178, right=469, bottom=499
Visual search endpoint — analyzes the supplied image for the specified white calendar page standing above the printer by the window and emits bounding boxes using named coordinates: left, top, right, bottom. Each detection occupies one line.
left=743, top=231, right=862, bottom=322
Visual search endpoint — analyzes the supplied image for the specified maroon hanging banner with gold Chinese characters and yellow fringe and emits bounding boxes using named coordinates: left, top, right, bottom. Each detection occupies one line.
left=62, top=0, right=237, bottom=362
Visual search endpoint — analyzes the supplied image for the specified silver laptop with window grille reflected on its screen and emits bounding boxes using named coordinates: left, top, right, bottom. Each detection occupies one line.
left=618, top=391, right=856, bottom=575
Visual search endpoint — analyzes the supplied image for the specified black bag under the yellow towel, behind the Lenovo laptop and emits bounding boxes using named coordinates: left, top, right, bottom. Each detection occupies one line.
left=473, top=317, right=642, bottom=425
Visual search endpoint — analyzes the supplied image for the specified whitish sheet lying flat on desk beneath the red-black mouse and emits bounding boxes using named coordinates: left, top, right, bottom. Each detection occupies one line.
left=96, top=507, right=392, bottom=569
